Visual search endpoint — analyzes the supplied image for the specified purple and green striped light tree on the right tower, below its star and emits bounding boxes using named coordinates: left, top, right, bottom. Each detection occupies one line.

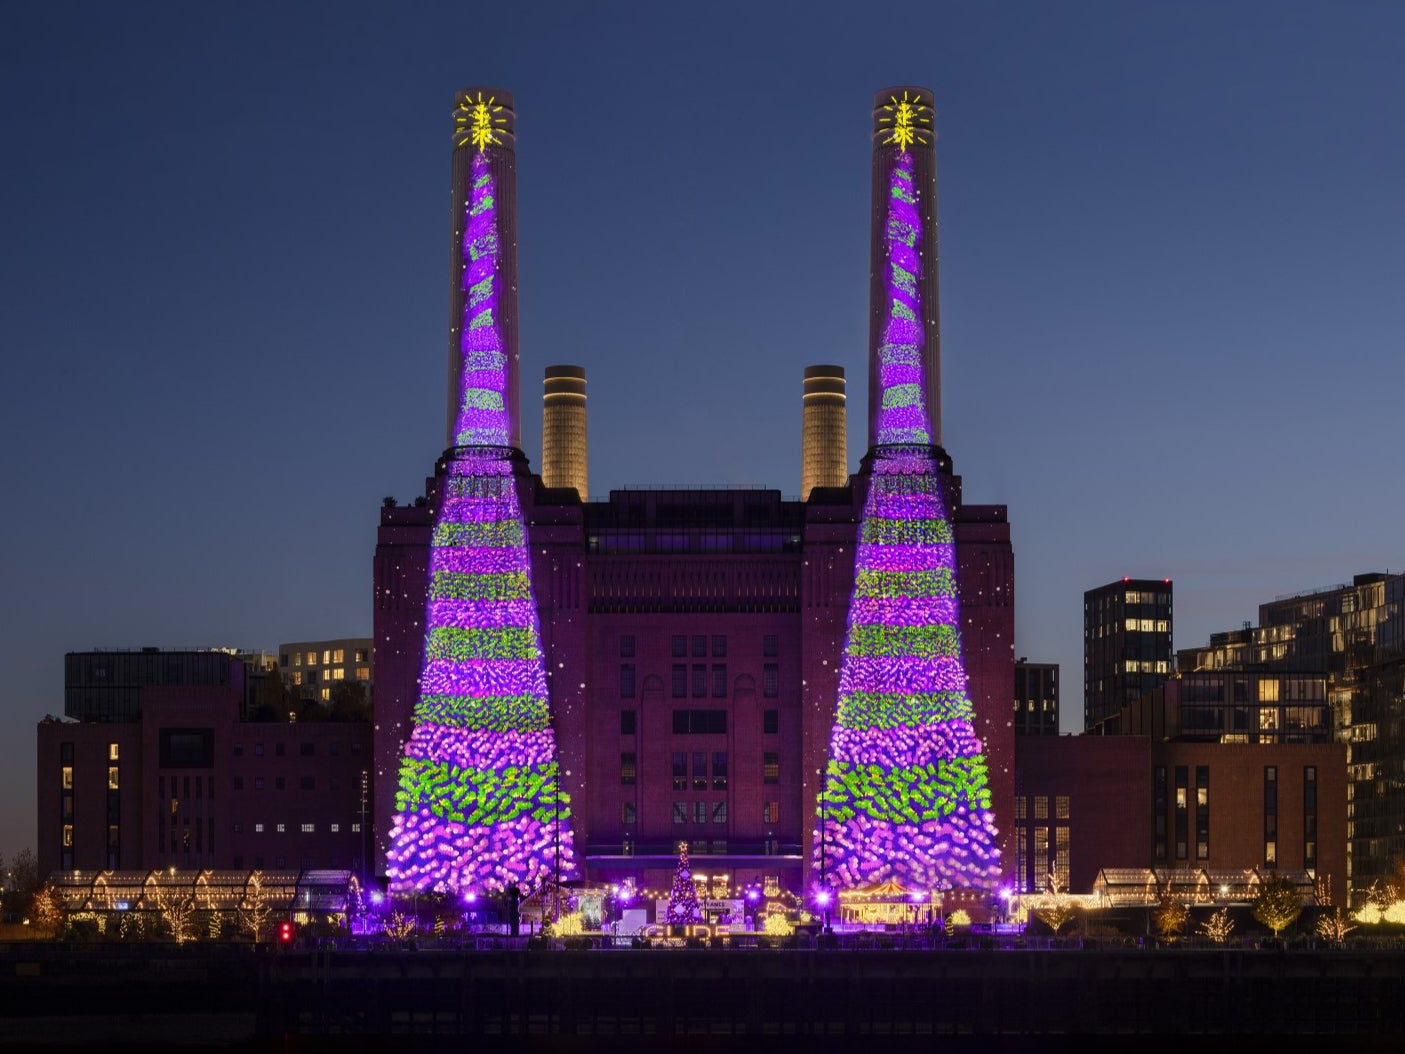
left=815, top=146, right=1000, bottom=890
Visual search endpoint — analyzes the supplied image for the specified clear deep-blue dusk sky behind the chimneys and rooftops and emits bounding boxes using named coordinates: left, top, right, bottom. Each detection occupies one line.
left=0, top=0, right=1405, bottom=859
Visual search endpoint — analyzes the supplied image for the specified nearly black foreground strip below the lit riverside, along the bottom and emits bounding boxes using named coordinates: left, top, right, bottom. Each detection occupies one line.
left=0, top=944, right=1405, bottom=1051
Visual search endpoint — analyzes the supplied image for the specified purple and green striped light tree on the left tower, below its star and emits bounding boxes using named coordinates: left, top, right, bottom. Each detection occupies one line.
left=386, top=132, right=576, bottom=892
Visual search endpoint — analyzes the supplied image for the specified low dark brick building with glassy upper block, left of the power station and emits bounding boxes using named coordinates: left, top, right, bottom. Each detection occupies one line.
left=37, top=648, right=371, bottom=874
